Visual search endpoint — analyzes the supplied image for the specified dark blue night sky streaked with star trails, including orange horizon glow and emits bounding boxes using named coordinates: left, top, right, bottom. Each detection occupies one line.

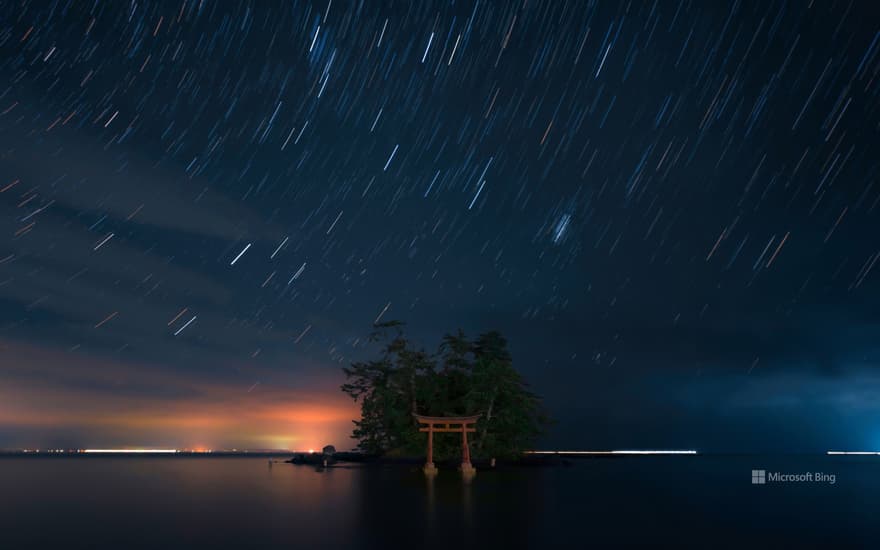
left=0, top=0, right=880, bottom=451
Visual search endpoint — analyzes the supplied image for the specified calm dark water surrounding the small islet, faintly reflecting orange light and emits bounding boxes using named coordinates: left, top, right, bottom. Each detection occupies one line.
left=0, top=456, right=880, bottom=549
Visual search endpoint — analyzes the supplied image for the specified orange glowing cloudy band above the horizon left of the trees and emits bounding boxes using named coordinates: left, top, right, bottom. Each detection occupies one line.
left=0, top=344, right=360, bottom=450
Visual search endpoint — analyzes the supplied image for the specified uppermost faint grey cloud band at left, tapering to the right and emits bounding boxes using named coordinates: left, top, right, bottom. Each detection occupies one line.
left=0, top=100, right=280, bottom=243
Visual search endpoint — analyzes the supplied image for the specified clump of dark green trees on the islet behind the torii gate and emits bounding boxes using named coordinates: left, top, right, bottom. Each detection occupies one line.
left=341, top=321, right=549, bottom=459
